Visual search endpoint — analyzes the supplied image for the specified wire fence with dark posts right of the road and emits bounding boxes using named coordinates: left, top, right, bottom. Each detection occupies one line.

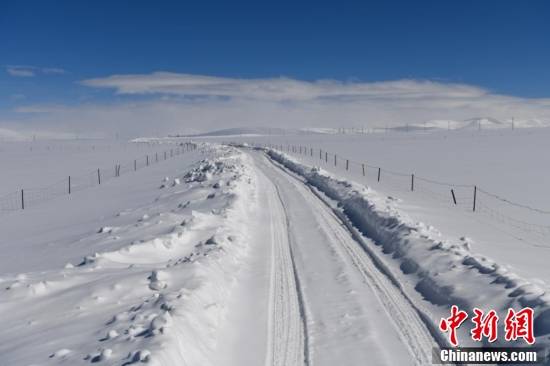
left=258, top=143, right=550, bottom=248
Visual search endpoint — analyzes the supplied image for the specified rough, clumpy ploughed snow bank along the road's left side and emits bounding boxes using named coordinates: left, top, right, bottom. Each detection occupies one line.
left=0, top=148, right=258, bottom=365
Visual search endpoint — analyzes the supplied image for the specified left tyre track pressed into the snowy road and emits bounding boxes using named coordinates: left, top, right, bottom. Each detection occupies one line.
left=265, top=170, right=309, bottom=366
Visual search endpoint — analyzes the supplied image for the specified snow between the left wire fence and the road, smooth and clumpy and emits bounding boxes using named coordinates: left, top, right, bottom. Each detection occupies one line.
left=0, top=142, right=256, bottom=365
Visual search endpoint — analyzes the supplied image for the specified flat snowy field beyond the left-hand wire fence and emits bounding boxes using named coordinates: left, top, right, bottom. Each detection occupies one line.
left=0, top=140, right=188, bottom=214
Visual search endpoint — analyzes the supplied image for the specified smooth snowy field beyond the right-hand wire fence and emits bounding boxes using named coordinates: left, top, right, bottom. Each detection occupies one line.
left=213, top=128, right=550, bottom=211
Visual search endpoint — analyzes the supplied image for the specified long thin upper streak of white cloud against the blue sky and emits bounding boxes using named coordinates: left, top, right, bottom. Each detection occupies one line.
left=82, top=72, right=487, bottom=101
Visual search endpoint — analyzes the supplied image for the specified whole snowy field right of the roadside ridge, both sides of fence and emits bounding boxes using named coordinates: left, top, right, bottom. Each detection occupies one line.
left=220, top=129, right=550, bottom=279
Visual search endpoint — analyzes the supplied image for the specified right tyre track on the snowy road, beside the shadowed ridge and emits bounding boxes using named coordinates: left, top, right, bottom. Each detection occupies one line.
left=267, top=152, right=437, bottom=365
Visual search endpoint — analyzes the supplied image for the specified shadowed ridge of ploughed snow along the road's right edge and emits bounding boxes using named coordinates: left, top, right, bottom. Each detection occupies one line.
left=267, top=150, right=550, bottom=344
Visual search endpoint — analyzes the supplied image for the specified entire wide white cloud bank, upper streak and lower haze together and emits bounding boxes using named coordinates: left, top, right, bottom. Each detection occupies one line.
left=0, top=72, right=550, bottom=136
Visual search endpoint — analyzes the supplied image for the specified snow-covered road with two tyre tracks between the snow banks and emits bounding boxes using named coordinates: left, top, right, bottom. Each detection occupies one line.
left=246, top=152, right=435, bottom=365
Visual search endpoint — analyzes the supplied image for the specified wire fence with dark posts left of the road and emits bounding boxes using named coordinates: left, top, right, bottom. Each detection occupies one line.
left=0, top=142, right=197, bottom=214
